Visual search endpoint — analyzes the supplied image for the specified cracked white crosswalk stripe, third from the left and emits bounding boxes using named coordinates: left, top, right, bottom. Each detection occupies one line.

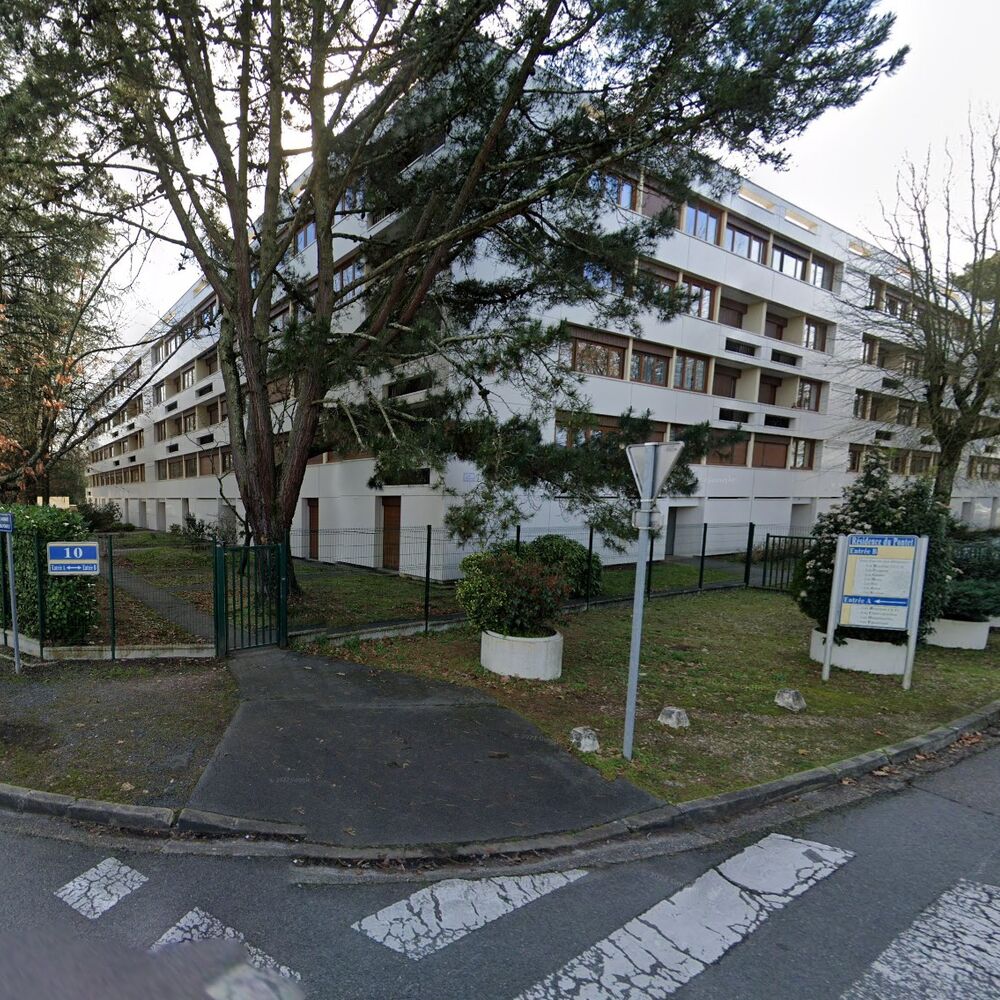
left=351, top=868, right=587, bottom=961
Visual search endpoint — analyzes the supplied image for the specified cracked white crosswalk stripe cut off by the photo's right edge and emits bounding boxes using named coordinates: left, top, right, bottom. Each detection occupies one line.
left=841, top=880, right=1000, bottom=1000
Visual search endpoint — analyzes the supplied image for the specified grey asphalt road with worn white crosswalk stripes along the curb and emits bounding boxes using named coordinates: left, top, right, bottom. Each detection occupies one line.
left=0, top=749, right=1000, bottom=1000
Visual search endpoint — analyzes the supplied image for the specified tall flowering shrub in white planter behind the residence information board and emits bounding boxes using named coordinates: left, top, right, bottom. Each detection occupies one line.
left=794, top=453, right=955, bottom=674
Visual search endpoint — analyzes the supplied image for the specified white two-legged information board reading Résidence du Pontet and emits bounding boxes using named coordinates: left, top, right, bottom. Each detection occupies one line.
left=823, top=535, right=927, bottom=691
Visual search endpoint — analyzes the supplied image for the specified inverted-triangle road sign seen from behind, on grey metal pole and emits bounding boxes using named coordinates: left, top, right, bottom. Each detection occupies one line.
left=622, top=441, right=684, bottom=760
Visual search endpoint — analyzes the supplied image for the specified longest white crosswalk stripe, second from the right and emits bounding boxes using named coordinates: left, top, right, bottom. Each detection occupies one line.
left=518, top=833, right=854, bottom=1000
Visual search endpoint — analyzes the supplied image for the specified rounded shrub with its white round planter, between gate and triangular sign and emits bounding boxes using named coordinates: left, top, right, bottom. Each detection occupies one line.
left=457, top=551, right=568, bottom=680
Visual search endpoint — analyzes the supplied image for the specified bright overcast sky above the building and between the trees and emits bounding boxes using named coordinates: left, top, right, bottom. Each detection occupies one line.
left=122, top=0, right=1000, bottom=339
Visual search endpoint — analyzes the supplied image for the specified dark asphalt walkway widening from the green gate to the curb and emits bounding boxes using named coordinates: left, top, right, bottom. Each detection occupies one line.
left=189, top=649, right=660, bottom=847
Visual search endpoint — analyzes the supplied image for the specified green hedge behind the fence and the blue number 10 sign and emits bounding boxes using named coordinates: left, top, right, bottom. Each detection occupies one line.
left=3, top=505, right=97, bottom=646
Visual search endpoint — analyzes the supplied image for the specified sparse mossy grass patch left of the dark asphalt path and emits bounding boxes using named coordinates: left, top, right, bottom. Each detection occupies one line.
left=0, top=660, right=237, bottom=806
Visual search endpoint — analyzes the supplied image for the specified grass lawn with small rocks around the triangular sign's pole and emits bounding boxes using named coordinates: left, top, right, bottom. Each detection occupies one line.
left=305, top=590, right=1000, bottom=802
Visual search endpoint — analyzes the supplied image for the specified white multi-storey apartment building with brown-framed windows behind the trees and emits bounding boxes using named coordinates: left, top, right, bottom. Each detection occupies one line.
left=87, top=172, right=1000, bottom=568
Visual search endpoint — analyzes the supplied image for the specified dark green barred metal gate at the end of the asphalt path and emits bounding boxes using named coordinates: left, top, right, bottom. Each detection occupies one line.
left=214, top=545, right=288, bottom=656
